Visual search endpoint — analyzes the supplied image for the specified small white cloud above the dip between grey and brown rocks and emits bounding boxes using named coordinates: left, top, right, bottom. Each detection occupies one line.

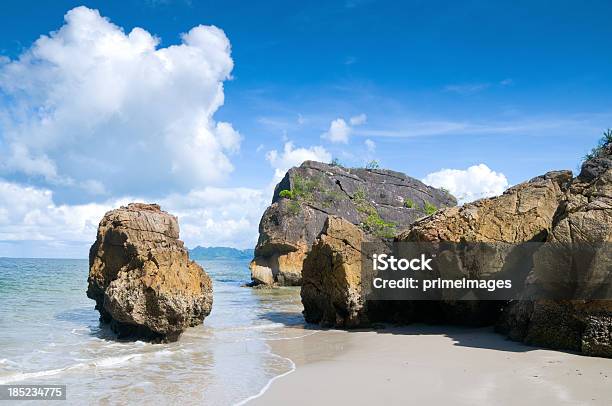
left=423, top=164, right=508, bottom=204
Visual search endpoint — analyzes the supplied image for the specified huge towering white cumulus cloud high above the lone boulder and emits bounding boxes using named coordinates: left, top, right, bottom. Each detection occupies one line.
left=0, top=7, right=241, bottom=196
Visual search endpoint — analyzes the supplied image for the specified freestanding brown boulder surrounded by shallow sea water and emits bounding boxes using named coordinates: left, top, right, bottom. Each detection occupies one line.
left=87, top=203, right=212, bottom=341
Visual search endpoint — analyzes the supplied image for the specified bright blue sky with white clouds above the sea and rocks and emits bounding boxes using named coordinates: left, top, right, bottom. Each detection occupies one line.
left=0, top=0, right=612, bottom=258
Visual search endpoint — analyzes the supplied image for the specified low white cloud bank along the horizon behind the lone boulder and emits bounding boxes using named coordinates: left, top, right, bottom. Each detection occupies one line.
left=0, top=179, right=269, bottom=258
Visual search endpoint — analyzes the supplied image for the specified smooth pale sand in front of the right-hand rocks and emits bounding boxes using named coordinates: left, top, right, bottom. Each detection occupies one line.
left=248, top=326, right=612, bottom=405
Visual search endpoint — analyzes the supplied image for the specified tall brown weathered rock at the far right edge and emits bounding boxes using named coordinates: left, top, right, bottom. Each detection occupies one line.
left=497, top=145, right=612, bottom=357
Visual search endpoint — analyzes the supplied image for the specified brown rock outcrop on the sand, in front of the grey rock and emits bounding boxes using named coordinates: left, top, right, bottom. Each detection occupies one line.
left=302, top=144, right=612, bottom=357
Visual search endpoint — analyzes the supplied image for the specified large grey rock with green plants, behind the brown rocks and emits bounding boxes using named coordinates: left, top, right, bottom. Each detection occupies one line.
left=250, top=161, right=456, bottom=285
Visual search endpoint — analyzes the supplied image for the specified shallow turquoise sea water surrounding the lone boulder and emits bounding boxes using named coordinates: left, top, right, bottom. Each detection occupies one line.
left=0, top=258, right=303, bottom=405
